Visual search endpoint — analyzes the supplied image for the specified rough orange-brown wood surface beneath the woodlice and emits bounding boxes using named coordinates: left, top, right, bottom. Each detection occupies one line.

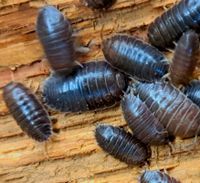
left=0, top=0, right=200, bottom=183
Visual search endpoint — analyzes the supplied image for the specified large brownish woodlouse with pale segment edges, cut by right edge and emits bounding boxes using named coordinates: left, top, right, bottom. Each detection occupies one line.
left=135, top=82, right=200, bottom=138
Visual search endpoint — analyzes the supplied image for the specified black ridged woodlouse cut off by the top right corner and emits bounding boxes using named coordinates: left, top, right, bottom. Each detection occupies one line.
left=148, top=0, right=200, bottom=48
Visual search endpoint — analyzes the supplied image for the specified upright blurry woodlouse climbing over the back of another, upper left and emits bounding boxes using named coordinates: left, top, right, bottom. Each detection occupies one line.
left=36, top=6, right=75, bottom=73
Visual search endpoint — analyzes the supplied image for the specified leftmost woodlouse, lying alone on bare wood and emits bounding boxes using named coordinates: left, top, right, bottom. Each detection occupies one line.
left=3, top=82, right=52, bottom=142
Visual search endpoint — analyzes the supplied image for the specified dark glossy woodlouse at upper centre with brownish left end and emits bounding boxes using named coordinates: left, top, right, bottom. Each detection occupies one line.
left=103, top=35, right=168, bottom=81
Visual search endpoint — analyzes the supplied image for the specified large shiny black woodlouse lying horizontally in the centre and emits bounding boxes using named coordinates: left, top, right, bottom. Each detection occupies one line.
left=43, top=61, right=126, bottom=112
